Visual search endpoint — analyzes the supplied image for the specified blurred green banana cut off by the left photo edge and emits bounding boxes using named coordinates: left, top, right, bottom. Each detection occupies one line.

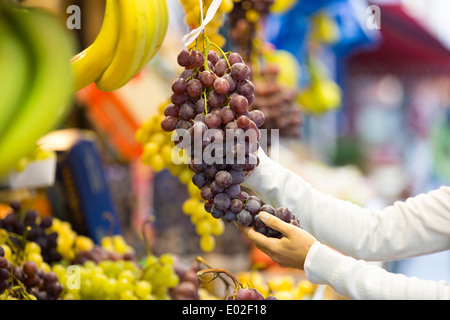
left=0, top=8, right=32, bottom=137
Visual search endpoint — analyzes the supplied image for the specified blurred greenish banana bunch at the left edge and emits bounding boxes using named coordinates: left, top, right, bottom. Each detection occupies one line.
left=0, top=1, right=75, bottom=176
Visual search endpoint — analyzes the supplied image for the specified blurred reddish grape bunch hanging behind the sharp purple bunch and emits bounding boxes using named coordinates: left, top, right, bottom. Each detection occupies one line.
left=249, top=64, right=303, bottom=145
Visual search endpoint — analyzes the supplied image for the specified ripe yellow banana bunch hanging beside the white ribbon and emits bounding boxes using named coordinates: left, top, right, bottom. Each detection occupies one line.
left=71, top=0, right=169, bottom=92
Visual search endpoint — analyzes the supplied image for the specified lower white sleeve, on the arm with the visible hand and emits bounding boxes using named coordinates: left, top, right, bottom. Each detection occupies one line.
left=305, top=242, right=450, bottom=300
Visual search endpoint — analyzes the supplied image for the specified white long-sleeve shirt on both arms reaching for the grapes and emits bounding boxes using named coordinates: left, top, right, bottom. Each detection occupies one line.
left=242, top=152, right=450, bottom=300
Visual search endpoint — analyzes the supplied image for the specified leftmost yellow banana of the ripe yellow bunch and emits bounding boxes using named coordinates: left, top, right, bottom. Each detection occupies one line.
left=71, top=0, right=119, bottom=91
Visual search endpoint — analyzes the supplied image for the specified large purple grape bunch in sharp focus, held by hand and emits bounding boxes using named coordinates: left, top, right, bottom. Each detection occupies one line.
left=161, top=36, right=300, bottom=238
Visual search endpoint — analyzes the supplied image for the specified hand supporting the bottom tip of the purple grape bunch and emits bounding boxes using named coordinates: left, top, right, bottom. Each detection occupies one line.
left=239, top=212, right=317, bottom=270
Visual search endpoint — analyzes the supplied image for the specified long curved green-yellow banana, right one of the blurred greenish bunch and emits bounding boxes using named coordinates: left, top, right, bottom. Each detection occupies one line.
left=0, top=6, right=75, bottom=175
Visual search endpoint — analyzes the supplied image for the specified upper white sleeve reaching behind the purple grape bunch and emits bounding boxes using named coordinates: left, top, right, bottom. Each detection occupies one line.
left=242, top=149, right=450, bottom=261
